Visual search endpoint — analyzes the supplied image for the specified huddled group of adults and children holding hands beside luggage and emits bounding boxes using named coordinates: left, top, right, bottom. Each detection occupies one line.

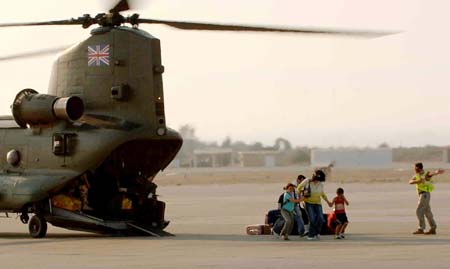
left=279, top=170, right=349, bottom=240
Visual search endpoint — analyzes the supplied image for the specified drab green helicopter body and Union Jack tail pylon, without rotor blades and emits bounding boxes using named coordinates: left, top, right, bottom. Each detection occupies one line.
left=0, top=27, right=182, bottom=234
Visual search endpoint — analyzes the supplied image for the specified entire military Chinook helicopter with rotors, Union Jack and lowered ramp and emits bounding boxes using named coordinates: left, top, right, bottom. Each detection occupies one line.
left=0, top=0, right=391, bottom=238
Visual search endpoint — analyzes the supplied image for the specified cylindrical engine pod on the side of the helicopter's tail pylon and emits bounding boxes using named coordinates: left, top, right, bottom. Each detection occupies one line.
left=12, top=89, right=84, bottom=128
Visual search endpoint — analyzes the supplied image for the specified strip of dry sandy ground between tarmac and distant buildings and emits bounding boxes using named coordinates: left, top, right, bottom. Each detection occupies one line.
left=156, top=163, right=450, bottom=186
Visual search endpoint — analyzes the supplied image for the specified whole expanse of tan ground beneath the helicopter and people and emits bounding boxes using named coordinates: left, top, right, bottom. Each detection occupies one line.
left=0, top=166, right=450, bottom=269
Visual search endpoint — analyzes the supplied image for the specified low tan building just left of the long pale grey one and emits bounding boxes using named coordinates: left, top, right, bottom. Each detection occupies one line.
left=238, top=151, right=287, bottom=167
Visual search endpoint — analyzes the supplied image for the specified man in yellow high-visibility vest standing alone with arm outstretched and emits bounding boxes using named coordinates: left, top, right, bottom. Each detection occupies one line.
left=409, top=163, right=444, bottom=234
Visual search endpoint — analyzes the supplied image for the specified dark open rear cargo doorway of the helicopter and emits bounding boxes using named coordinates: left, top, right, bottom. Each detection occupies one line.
left=48, top=139, right=181, bottom=229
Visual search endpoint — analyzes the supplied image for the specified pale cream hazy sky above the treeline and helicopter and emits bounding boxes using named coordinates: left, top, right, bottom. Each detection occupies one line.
left=0, top=0, right=450, bottom=146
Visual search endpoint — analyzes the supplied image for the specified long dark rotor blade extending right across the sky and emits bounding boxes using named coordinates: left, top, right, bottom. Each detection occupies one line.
left=137, top=19, right=396, bottom=37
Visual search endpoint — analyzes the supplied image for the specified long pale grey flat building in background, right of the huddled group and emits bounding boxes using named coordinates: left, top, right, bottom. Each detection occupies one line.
left=311, top=148, right=392, bottom=168
